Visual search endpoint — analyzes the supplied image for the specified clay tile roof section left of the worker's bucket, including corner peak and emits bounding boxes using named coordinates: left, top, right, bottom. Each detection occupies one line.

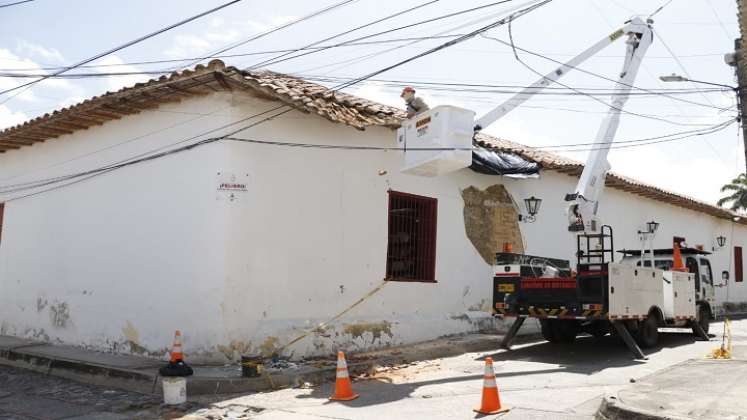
left=0, top=60, right=404, bottom=153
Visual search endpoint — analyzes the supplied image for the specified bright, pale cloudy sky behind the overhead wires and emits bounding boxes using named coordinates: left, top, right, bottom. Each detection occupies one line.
left=0, top=0, right=745, bottom=203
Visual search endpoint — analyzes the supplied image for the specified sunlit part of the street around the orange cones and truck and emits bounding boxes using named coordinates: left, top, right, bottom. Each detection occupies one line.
left=188, top=320, right=747, bottom=420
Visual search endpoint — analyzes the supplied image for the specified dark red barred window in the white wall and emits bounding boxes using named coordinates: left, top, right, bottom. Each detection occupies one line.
left=386, top=191, right=438, bottom=282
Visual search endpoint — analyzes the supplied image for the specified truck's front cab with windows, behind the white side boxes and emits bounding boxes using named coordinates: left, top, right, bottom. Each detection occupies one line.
left=618, top=248, right=720, bottom=332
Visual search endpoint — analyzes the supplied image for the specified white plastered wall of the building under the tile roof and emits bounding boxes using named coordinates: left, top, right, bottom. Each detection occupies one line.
left=0, top=94, right=747, bottom=357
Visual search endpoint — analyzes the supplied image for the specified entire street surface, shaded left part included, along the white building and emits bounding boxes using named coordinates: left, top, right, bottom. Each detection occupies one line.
left=0, top=320, right=747, bottom=420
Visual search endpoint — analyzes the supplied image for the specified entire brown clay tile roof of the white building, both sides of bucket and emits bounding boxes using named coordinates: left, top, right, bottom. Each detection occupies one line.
left=0, top=60, right=747, bottom=224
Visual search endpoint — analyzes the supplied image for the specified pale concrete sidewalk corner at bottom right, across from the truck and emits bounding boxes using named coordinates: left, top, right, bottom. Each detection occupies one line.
left=597, top=343, right=747, bottom=420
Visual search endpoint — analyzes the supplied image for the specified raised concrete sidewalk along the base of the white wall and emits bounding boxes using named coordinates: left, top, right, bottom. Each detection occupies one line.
left=0, top=334, right=516, bottom=395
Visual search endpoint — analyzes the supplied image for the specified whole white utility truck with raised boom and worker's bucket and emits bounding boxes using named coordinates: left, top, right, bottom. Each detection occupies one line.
left=398, top=17, right=714, bottom=359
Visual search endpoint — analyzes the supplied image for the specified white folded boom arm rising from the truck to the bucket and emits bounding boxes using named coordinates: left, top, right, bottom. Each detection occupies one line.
left=475, top=17, right=653, bottom=232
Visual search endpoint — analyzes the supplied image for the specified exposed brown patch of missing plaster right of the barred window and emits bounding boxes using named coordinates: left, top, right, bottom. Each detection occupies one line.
left=462, top=185, right=524, bottom=265
